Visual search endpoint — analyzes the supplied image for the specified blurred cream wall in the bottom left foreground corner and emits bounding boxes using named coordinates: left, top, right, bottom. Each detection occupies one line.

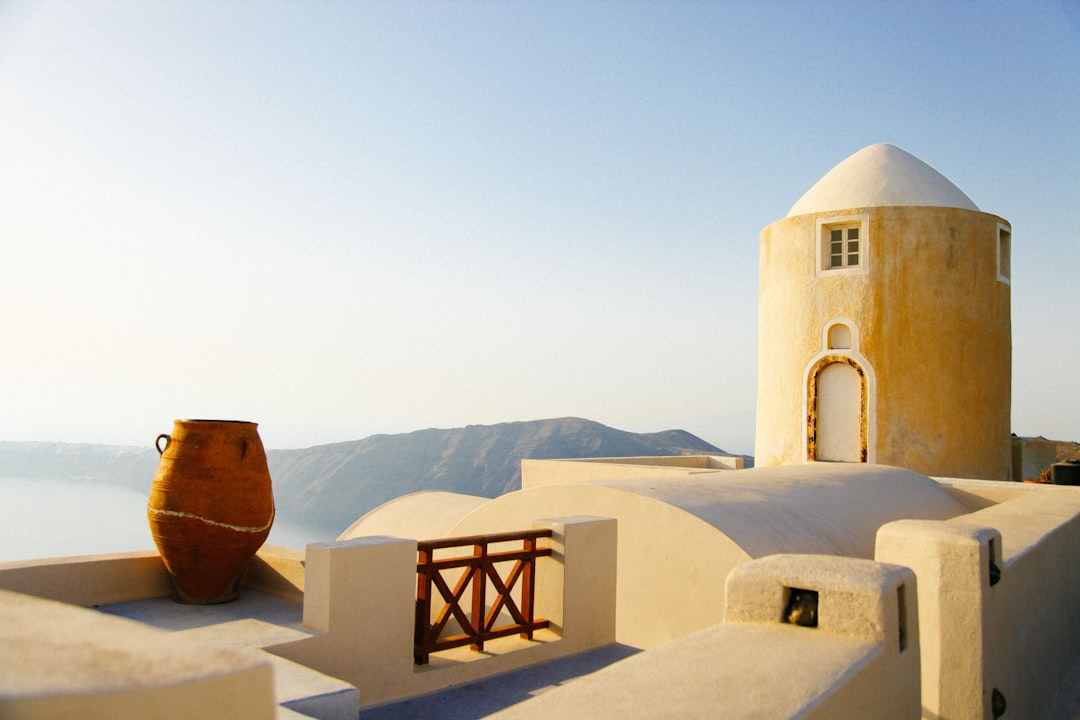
left=0, top=590, right=278, bottom=720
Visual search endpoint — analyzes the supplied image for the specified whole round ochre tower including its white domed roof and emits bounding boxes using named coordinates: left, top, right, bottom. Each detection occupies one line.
left=755, top=145, right=1012, bottom=480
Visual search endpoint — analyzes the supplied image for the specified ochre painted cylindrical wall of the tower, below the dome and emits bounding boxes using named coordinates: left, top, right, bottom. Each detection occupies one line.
left=755, top=206, right=1012, bottom=480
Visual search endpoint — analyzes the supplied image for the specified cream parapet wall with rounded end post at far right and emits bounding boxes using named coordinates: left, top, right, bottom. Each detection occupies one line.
left=876, top=484, right=1080, bottom=719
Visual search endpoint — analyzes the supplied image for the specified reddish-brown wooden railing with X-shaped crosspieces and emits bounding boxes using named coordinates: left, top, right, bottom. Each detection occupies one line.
left=413, top=529, right=552, bottom=665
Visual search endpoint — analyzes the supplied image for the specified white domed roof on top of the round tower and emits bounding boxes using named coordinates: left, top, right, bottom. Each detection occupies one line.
left=787, top=145, right=978, bottom=217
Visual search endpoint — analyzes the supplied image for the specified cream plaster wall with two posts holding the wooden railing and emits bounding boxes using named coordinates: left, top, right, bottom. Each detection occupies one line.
left=265, top=517, right=618, bottom=707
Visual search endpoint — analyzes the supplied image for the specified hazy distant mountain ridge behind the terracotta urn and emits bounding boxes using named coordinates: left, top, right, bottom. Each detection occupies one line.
left=0, top=418, right=752, bottom=532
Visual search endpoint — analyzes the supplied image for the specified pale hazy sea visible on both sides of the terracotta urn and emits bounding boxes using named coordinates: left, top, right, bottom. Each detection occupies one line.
left=0, top=477, right=336, bottom=562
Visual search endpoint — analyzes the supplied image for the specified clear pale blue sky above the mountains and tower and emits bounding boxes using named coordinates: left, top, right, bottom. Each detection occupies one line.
left=0, top=0, right=1080, bottom=452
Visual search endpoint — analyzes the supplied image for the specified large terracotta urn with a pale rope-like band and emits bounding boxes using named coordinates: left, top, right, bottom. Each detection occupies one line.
left=147, top=420, right=274, bottom=604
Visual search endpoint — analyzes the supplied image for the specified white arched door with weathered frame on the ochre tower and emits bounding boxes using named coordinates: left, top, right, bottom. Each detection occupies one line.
left=807, top=355, right=866, bottom=462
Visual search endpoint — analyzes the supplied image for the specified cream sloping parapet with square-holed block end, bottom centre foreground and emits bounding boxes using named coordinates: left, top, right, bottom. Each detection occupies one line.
left=495, top=555, right=920, bottom=720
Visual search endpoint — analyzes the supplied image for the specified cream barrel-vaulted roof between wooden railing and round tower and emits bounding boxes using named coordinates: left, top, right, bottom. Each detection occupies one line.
left=425, top=461, right=970, bottom=648
